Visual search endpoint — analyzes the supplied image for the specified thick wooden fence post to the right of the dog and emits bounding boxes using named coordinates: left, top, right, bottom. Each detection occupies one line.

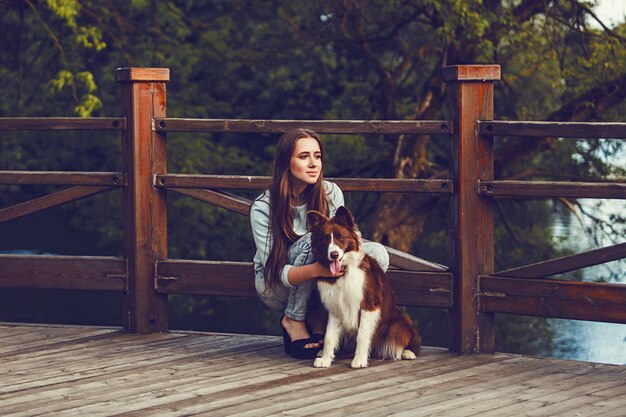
left=444, top=65, right=500, bottom=354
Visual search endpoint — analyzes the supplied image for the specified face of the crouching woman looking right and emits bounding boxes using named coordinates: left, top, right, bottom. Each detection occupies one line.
left=289, top=138, right=322, bottom=192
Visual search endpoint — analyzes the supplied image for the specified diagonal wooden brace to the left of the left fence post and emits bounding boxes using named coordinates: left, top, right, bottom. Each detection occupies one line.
left=0, top=185, right=115, bottom=223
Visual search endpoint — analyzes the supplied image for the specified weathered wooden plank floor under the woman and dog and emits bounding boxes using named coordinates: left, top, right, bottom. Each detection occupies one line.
left=0, top=323, right=626, bottom=417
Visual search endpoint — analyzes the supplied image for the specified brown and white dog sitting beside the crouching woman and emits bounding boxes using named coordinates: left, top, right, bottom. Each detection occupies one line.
left=307, top=207, right=421, bottom=368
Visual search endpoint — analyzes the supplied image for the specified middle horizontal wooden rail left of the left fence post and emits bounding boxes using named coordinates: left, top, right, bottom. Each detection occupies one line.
left=0, top=171, right=126, bottom=186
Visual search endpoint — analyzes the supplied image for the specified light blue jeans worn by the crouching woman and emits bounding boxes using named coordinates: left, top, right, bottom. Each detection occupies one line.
left=254, top=233, right=389, bottom=321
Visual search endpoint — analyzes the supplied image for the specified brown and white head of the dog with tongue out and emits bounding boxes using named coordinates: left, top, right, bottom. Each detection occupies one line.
left=307, top=206, right=361, bottom=273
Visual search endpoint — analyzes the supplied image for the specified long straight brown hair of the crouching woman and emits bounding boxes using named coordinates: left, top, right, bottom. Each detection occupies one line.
left=264, top=129, right=328, bottom=286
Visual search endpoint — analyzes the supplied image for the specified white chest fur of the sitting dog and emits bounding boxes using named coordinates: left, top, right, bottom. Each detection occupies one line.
left=317, top=267, right=365, bottom=330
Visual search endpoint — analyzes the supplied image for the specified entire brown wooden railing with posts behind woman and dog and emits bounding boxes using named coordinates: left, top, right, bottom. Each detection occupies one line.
left=0, top=65, right=626, bottom=353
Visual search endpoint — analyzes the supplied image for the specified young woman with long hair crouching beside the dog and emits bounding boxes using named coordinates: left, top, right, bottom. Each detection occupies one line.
left=250, top=129, right=389, bottom=359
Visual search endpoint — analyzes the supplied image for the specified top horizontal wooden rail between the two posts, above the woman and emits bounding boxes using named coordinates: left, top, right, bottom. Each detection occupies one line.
left=154, top=118, right=453, bottom=135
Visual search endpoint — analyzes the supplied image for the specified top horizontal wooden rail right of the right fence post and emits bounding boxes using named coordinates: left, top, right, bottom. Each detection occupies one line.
left=478, top=120, right=626, bottom=139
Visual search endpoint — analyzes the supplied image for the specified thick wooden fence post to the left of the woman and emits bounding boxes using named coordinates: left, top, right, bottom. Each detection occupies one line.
left=115, top=68, right=169, bottom=334
